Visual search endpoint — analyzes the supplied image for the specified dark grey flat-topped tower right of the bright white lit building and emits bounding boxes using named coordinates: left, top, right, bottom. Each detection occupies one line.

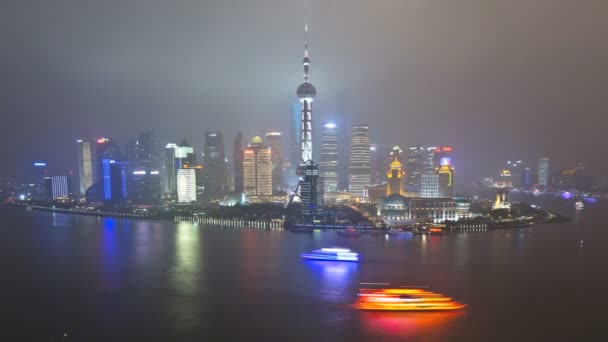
left=203, top=131, right=228, bottom=199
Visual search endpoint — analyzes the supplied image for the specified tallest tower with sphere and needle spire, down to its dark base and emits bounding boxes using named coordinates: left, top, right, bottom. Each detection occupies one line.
left=296, top=18, right=323, bottom=222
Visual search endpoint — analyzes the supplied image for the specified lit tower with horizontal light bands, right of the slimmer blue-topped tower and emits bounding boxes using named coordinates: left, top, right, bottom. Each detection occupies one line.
left=348, top=124, right=371, bottom=200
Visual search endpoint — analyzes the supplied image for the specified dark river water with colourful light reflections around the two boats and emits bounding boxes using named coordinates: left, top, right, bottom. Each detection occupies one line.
left=0, top=195, right=608, bottom=341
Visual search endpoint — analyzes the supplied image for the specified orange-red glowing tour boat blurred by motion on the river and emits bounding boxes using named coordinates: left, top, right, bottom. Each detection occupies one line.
left=354, top=287, right=466, bottom=311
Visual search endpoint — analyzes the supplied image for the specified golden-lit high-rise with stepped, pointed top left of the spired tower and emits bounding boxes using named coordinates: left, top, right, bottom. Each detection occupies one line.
left=243, top=136, right=272, bottom=198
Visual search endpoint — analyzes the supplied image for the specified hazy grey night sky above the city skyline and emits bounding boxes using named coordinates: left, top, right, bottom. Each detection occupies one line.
left=0, top=0, right=608, bottom=187
